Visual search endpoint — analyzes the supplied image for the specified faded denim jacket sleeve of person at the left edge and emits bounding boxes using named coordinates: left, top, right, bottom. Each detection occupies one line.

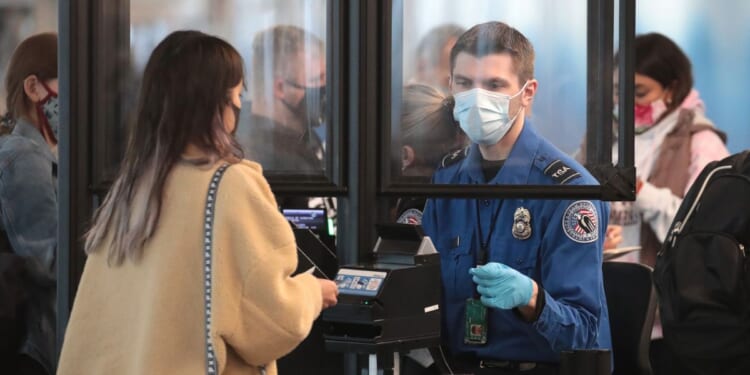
left=0, top=149, right=57, bottom=272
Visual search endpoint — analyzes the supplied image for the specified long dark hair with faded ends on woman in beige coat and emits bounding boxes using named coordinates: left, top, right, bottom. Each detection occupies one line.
left=86, top=31, right=244, bottom=264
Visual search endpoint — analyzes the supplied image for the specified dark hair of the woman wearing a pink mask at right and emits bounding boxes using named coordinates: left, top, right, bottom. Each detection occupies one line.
left=635, top=33, right=693, bottom=110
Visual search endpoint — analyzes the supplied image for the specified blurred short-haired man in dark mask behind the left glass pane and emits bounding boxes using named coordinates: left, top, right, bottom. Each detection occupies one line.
left=237, top=25, right=326, bottom=174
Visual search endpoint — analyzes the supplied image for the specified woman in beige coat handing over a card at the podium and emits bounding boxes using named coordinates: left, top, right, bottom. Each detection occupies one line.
left=58, top=31, right=337, bottom=375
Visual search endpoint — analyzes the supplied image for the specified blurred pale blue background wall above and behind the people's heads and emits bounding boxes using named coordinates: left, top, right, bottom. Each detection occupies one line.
left=0, top=0, right=750, bottom=152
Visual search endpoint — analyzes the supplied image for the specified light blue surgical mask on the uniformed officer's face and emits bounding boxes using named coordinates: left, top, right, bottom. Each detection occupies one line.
left=453, top=81, right=529, bottom=146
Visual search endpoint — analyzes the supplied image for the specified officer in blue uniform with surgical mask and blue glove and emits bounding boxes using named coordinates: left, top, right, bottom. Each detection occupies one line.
left=422, top=22, right=612, bottom=375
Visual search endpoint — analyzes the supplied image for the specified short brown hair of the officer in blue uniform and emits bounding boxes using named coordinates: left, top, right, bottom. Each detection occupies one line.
left=451, top=21, right=534, bottom=85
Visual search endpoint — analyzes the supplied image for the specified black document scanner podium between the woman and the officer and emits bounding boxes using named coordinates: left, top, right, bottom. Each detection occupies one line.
left=322, top=224, right=441, bottom=374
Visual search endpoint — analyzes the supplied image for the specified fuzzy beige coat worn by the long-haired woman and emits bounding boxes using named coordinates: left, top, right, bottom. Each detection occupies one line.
left=58, top=161, right=322, bottom=375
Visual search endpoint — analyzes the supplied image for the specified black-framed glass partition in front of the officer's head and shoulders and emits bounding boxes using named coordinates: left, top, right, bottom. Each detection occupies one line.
left=381, top=0, right=632, bottom=203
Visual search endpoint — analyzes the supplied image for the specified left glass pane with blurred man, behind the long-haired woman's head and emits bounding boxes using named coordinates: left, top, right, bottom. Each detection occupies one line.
left=118, top=0, right=331, bottom=182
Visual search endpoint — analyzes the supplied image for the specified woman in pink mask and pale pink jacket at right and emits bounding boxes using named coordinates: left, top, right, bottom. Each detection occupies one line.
left=610, top=33, right=729, bottom=267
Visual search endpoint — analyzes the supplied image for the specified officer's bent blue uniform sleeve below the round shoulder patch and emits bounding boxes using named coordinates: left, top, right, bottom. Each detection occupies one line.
left=534, top=201, right=609, bottom=352
